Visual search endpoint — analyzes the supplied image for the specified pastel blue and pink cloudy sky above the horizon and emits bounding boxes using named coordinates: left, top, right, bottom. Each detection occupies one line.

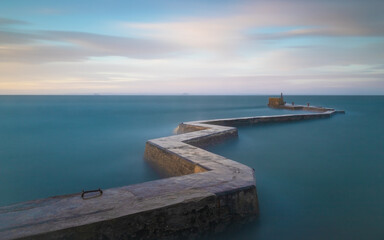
left=0, top=0, right=384, bottom=95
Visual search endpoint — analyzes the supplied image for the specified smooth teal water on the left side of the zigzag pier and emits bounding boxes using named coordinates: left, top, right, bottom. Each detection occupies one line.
left=0, top=96, right=294, bottom=206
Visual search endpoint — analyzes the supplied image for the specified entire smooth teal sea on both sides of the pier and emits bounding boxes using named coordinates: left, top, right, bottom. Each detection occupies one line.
left=0, top=95, right=384, bottom=240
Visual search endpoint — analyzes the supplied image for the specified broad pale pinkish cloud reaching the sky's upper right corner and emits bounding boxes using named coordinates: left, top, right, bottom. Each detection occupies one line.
left=123, top=0, right=384, bottom=48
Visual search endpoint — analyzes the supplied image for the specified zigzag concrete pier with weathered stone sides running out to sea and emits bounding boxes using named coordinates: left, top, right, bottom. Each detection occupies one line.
left=0, top=105, right=344, bottom=240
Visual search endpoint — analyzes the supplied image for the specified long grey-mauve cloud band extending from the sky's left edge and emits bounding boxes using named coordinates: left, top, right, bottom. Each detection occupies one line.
left=0, top=31, right=182, bottom=63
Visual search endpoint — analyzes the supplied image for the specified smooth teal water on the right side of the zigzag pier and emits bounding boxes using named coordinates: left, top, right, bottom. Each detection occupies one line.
left=209, top=96, right=384, bottom=240
